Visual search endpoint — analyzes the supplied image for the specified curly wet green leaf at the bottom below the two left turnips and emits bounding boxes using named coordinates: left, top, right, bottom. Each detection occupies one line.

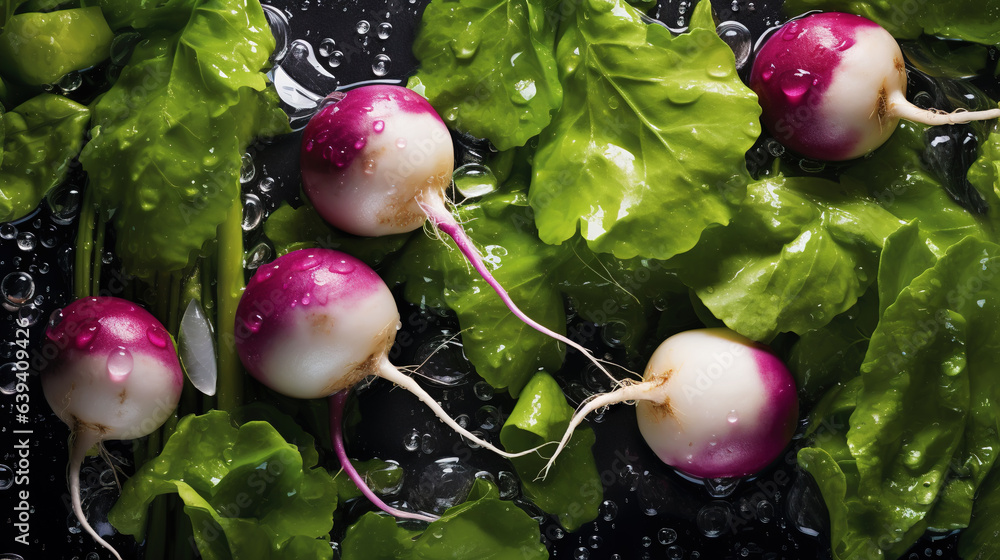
left=109, top=411, right=337, bottom=559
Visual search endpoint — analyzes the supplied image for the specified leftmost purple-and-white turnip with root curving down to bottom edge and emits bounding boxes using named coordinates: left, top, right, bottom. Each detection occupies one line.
left=41, top=297, right=184, bottom=560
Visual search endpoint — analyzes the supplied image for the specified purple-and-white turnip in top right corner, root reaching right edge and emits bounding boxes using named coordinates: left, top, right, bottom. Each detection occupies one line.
left=750, top=12, right=1000, bottom=161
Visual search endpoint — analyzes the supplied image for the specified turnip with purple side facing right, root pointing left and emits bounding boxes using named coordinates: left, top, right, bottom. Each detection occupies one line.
left=541, top=329, right=798, bottom=478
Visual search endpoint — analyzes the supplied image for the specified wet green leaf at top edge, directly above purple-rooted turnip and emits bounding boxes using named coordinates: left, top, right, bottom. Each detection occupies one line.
left=413, top=0, right=562, bottom=150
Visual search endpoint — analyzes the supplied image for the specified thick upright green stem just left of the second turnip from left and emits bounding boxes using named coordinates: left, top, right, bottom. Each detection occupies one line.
left=216, top=197, right=246, bottom=412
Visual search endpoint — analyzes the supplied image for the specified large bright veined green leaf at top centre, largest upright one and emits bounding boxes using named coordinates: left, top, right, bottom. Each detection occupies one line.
left=530, top=0, right=760, bottom=259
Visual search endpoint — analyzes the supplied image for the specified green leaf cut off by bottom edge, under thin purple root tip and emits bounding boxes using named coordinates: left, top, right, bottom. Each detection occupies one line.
left=341, top=479, right=548, bottom=560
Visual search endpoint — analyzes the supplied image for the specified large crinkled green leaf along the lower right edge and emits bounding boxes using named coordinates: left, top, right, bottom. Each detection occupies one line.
left=799, top=232, right=1000, bottom=559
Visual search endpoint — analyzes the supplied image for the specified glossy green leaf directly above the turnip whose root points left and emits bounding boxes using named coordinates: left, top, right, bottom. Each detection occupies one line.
left=670, top=176, right=901, bottom=342
